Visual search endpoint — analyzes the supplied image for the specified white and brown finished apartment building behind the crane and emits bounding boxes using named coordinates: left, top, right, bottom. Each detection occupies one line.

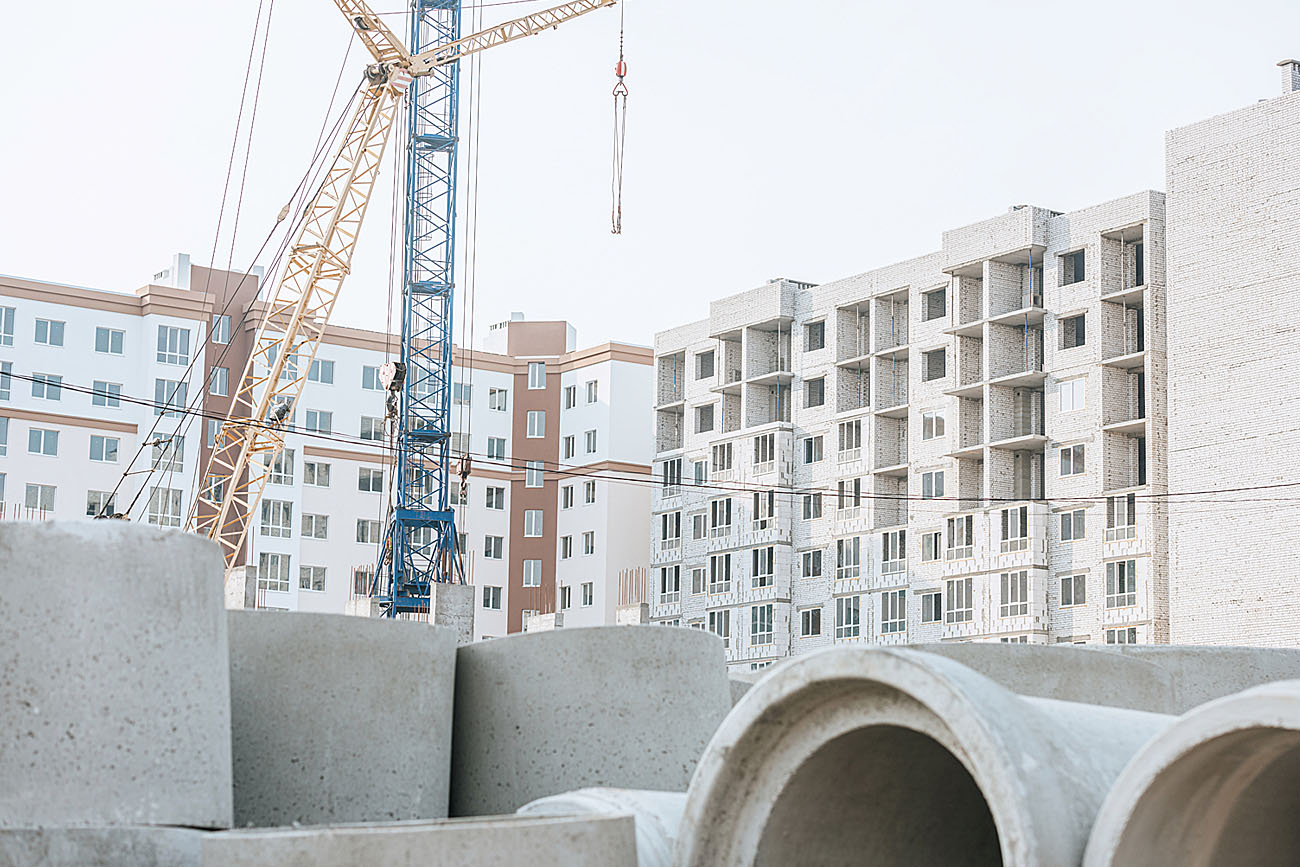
left=0, top=255, right=651, bottom=637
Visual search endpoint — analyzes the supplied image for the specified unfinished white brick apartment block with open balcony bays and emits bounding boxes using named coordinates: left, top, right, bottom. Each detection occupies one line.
left=651, top=192, right=1169, bottom=667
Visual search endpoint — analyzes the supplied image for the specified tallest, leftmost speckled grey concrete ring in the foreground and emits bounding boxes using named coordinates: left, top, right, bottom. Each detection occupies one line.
left=0, top=521, right=231, bottom=828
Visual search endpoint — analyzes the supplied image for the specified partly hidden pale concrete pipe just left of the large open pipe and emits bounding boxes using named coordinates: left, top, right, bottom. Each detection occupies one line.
left=517, top=788, right=686, bottom=867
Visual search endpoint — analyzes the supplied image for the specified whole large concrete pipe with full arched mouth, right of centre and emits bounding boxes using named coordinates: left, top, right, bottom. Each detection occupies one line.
left=676, top=647, right=1173, bottom=867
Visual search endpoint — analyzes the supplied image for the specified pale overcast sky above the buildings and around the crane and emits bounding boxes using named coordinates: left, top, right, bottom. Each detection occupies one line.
left=0, top=0, right=1300, bottom=346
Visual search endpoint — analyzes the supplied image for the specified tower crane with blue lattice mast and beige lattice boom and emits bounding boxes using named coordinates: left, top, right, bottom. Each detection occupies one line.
left=187, top=0, right=618, bottom=616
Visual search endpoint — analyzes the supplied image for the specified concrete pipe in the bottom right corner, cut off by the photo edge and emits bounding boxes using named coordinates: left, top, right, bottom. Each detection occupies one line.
left=1084, top=681, right=1300, bottom=867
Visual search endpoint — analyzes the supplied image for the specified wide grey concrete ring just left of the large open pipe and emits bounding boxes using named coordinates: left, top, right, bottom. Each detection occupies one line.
left=451, top=627, right=731, bottom=816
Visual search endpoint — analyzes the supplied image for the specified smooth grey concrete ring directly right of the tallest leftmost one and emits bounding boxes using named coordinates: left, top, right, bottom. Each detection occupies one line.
left=228, top=611, right=455, bottom=825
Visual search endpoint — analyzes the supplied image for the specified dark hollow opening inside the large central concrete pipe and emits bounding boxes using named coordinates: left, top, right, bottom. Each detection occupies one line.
left=755, top=725, right=1002, bottom=867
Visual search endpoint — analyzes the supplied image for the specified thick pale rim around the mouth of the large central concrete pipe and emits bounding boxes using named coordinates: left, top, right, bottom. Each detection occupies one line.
left=675, top=647, right=1040, bottom=866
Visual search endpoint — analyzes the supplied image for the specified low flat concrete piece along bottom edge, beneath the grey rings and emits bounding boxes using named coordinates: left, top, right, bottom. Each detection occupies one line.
left=203, top=816, right=637, bottom=867
